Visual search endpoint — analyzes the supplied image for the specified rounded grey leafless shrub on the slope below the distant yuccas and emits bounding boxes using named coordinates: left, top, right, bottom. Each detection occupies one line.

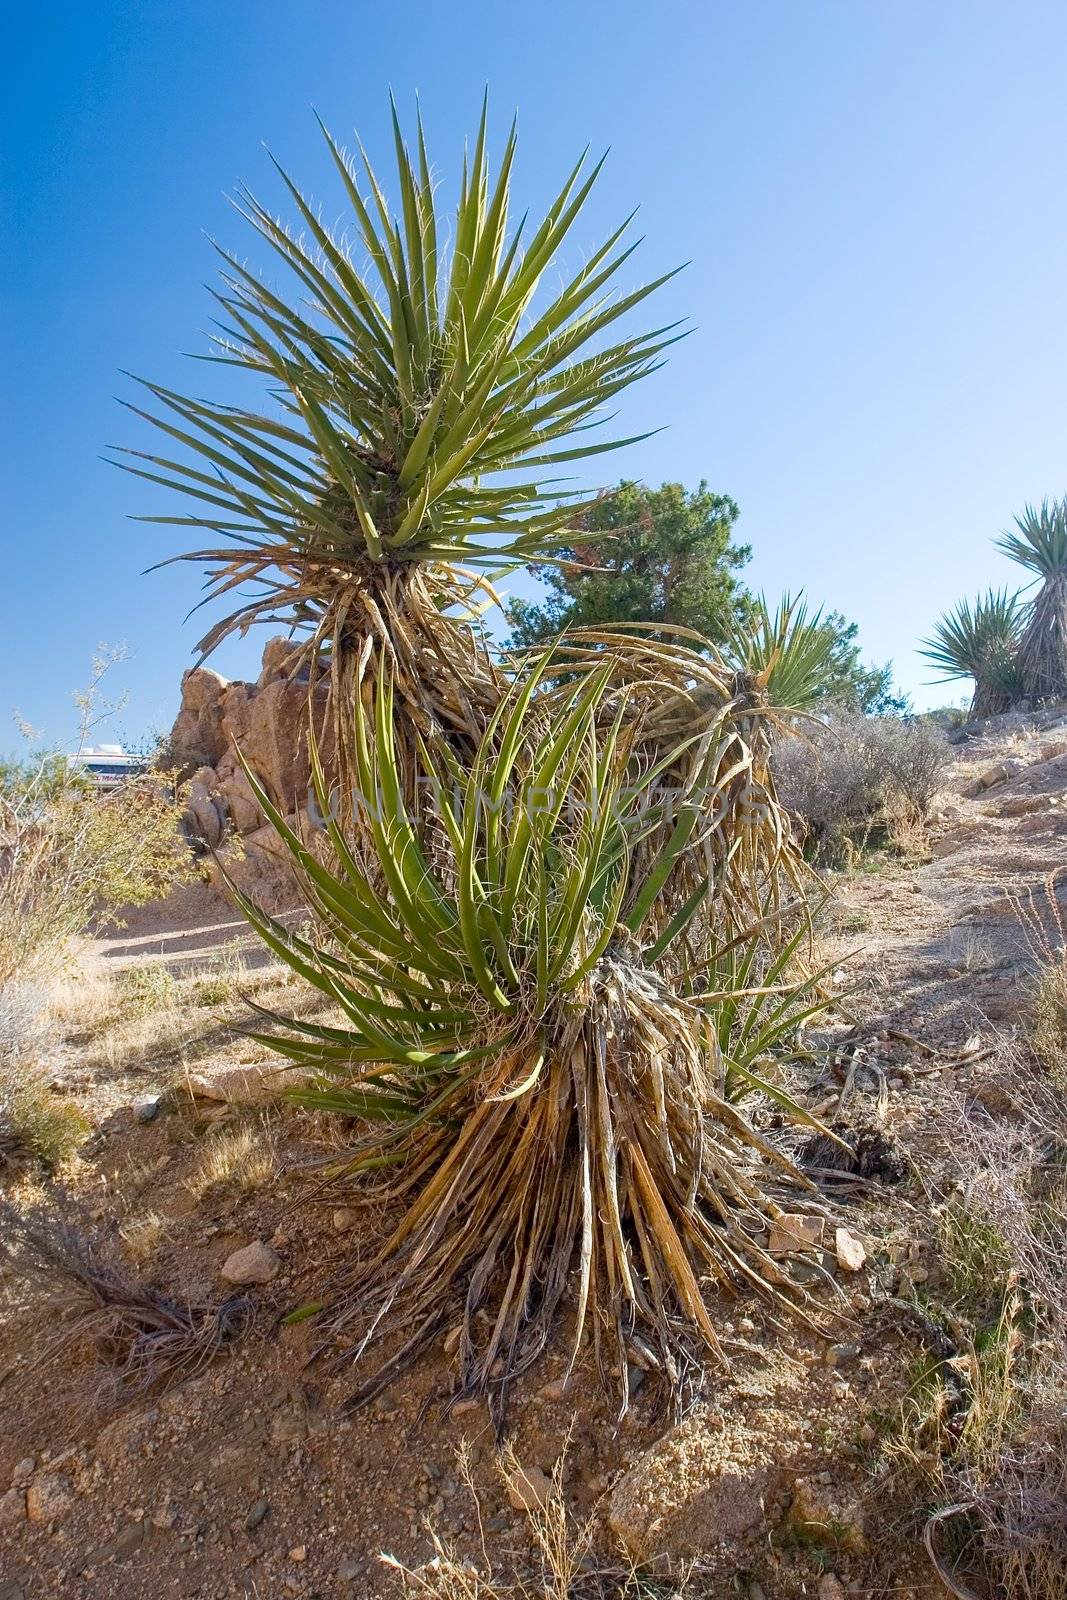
left=774, top=712, right=949, bottom=861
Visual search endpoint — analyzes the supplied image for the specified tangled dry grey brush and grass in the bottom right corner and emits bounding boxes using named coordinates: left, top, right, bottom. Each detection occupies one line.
left=889, top=1046, right=1067, bottom=1600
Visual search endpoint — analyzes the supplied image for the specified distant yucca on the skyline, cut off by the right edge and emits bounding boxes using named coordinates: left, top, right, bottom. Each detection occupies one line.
left=997, top=498, right=1067, bottom=701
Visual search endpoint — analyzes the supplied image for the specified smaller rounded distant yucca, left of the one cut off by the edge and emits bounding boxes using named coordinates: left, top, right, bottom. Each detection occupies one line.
left=920, top=589, right=1025, bottom=717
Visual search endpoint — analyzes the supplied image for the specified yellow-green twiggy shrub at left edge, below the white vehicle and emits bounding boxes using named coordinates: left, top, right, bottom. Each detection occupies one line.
left=0, top=757, right=192, bottom=984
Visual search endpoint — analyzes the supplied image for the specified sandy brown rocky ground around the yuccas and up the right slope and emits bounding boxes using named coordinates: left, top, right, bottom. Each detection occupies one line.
left=0, top=718, right=1067, bottom=1600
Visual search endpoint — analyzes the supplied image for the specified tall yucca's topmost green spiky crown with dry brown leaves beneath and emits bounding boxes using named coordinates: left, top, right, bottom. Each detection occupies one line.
left=116, top=96, right=680, bottom=796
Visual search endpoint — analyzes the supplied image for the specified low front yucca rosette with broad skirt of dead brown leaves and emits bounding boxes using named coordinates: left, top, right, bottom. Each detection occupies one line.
left=231, top=659, right=825, bottom=1419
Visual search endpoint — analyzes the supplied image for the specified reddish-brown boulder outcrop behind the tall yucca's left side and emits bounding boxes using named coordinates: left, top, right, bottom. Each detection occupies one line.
left=170, top=638, right=330, bottom=910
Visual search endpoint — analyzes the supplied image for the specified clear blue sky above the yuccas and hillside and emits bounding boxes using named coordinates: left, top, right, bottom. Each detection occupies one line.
left=0, top=0, right=1067, bottom=750
